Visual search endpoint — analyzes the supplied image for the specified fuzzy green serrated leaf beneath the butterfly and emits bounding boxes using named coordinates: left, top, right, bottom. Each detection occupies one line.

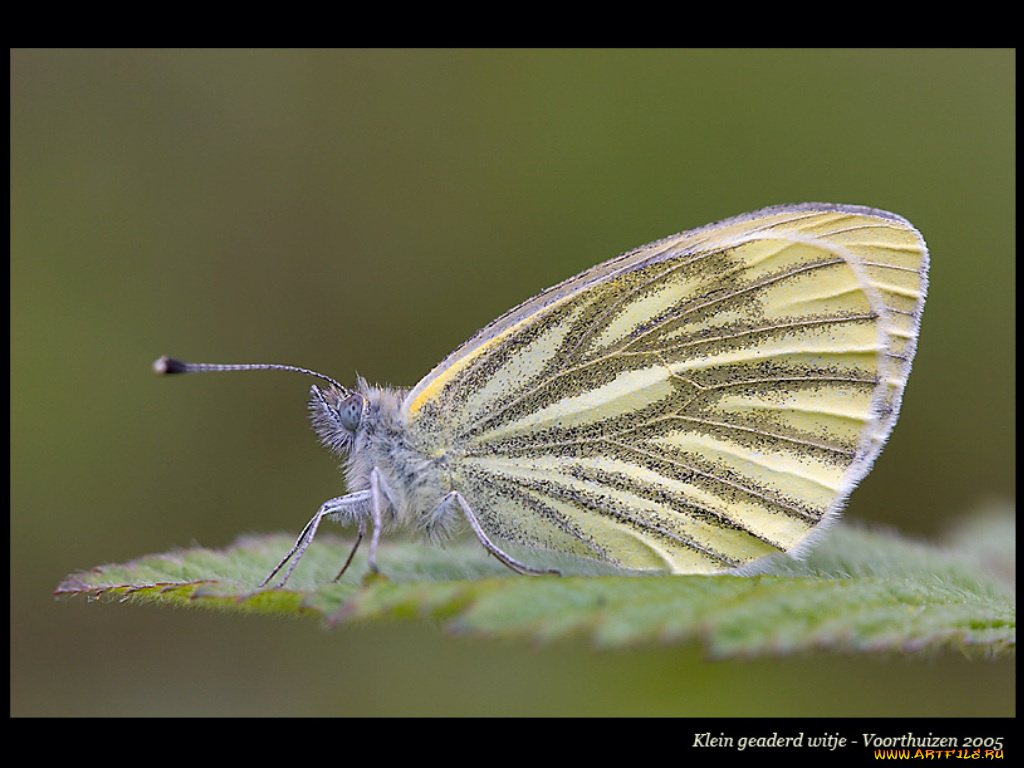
left=56, top=514, right=1017, bottom=657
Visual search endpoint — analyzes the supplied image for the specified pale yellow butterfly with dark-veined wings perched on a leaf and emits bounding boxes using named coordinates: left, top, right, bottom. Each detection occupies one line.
left=155, top=203, right=928, bottom=586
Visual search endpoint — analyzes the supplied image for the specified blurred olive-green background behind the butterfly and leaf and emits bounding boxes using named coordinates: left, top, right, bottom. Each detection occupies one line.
left=10, top=50, right=1016, bottom=716
